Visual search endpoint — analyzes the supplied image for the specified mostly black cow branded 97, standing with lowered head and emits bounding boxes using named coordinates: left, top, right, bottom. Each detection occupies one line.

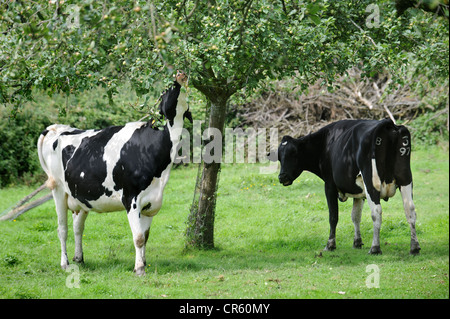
left=278, top=119, right=420, bottom=255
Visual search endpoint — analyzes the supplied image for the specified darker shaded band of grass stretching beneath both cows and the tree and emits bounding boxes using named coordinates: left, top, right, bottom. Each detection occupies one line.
left=46, top=220, right=449, bottom=274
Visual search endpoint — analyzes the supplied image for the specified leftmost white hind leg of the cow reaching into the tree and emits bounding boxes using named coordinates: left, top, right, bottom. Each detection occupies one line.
left=52, top=188, right=69, bottom=269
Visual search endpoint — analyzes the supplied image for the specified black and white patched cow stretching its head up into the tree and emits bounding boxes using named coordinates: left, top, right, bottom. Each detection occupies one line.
left=38, top=71, right=192, bottom=275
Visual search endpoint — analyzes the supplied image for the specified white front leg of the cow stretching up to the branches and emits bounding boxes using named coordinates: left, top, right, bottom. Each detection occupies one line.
left=128, top=210, right=153, bottom=276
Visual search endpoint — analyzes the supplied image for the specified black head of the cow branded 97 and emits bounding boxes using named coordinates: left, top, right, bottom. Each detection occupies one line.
left=278, top=136, right=303, bottom=186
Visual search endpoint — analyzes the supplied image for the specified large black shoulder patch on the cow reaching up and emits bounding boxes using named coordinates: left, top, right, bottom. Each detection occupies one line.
left=113, top=125, right=172, bottom=212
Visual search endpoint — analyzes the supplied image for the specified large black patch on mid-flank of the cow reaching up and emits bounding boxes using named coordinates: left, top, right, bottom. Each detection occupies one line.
left=61, top=126, right=123, bottom=208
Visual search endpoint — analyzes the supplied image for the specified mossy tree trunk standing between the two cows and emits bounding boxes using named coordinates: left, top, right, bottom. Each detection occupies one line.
left=186, top=94, right=228, bottom=249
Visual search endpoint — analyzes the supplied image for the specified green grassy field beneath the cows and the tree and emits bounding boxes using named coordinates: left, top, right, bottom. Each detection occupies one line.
left=0, top=147, right=449, bottom=299
